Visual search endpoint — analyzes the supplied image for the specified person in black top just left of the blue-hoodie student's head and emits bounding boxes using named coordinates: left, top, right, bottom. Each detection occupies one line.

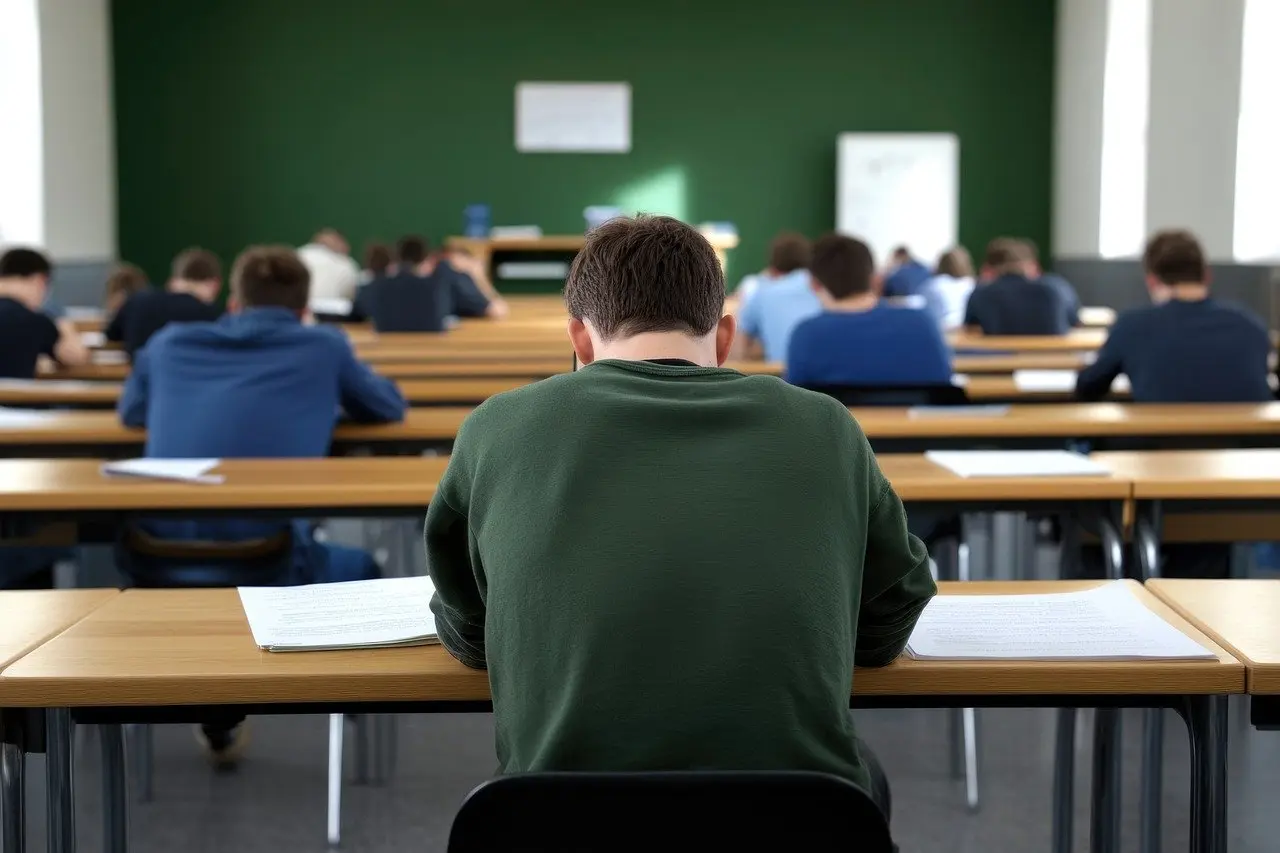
left=106, top=248, right=223, bottom=357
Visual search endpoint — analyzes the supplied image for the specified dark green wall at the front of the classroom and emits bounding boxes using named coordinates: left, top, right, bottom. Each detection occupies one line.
left=113, top=0, right=1053, bottom=286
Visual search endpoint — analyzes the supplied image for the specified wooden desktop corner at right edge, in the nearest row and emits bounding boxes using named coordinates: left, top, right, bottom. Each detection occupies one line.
left=1147, top=578, right=1280, bottom=694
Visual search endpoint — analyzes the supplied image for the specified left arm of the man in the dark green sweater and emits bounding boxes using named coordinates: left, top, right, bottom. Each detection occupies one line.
left=424, top=440, right=485, bottom=670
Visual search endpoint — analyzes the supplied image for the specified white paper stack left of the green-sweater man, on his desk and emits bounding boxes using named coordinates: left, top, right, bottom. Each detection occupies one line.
left=239, top=578, right=439, bottom=652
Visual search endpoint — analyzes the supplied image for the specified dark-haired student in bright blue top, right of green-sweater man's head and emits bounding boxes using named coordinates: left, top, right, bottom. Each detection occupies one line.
left=786, top=234, right=951, bottom=388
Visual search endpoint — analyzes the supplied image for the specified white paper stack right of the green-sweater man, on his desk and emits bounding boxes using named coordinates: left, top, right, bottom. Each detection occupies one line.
left=906, top=581, right=1216, bottom=661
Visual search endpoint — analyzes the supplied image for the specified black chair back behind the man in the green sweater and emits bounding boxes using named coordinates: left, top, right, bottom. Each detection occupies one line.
left=448, top=771, right=895, bottom=853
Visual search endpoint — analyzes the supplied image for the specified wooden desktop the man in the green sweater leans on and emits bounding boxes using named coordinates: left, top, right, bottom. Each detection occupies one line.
left=0, top=581, right=1244, bottom=707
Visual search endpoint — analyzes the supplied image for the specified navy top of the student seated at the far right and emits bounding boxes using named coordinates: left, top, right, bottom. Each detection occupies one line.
left=1075, top=298, right=1272, bottom=403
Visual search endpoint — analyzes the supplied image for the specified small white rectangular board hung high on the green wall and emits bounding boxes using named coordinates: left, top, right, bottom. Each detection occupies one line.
left=516, top=82, right=631, bottom=154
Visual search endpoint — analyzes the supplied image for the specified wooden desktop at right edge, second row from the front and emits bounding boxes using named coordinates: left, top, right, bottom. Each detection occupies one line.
left=1093, top=450, right=1280, bottom=500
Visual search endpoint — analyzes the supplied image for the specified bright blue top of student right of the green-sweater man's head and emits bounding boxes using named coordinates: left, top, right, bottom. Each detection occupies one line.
left=786, top=304, right=951, bottom=387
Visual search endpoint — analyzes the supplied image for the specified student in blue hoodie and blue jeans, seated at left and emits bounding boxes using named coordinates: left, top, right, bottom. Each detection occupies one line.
left=119, top=246, right=404, bottom=766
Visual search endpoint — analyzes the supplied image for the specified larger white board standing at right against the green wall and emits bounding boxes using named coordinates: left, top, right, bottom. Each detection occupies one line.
left=836, top=133, right=960, bottom=266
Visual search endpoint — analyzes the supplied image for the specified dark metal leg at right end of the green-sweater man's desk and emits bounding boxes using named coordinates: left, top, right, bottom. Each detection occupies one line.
left=1185, top=695, right=1228, bottom=853
